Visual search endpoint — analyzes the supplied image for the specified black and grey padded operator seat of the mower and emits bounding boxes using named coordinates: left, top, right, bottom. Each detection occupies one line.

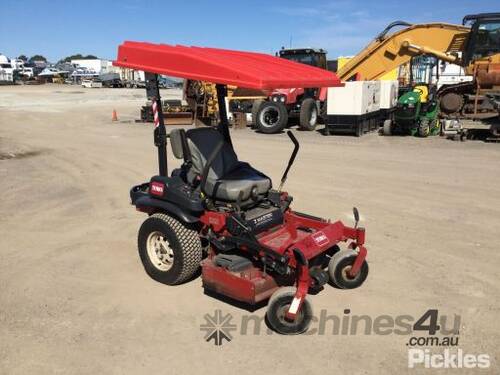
left=170, top=128, right=271, bottom=202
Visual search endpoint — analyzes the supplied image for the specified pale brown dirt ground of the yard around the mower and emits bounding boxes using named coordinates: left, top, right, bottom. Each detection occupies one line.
left=0, top=85, right=500, bottom=375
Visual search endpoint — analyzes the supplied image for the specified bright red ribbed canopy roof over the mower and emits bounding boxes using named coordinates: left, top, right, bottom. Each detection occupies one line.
left=113, top=42, right=341, bottom=90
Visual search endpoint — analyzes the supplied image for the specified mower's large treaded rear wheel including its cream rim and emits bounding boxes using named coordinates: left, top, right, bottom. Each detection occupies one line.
left=137, top=214, right=203, bottom=285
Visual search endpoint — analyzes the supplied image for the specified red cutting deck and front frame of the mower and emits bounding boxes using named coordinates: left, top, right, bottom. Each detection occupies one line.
left=202, top=211, right=366, bottom=305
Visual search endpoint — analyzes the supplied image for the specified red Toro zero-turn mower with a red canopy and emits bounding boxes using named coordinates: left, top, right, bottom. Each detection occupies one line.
left=115, top=42, right=368, bottom=334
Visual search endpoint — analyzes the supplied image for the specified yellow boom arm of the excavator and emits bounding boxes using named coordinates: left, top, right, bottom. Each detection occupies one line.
left=337, top=21, right=470, bottom=81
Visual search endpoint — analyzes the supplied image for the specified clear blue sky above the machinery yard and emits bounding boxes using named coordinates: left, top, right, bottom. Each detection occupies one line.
left=0, top=0, right=500, bottom=62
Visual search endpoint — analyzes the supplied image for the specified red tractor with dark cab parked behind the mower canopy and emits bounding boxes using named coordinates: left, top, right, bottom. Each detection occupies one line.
left=252, top=48, right=327, bottom=134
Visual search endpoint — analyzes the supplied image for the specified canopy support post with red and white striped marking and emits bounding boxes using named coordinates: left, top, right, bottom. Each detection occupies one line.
left=144, top=72, right=168, bottom=177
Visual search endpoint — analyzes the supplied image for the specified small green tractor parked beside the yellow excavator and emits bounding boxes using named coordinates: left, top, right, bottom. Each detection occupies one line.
left=383, top=84, right=440, bottom=137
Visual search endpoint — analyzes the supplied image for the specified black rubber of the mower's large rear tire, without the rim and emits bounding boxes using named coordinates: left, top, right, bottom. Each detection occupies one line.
left=137, top=214, right=203, bottom=285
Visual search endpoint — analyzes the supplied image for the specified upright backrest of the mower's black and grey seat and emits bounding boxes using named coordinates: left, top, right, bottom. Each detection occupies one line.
left=186, top=127, right=239, bottom=185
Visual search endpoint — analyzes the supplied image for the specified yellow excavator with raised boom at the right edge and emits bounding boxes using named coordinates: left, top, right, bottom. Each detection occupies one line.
left=337, top=13, right=500, bottom=137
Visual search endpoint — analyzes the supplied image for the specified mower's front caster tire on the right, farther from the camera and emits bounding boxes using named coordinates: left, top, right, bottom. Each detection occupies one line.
left=328, top=250, right=368, bottom=289
